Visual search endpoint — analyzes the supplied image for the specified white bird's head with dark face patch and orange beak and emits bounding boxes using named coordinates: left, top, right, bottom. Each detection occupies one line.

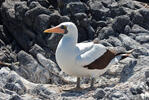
left=44, top=22, right=78, bottom=35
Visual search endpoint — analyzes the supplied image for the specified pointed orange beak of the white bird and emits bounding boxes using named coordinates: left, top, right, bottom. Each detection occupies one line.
left=44, top=26, right=65, bottom=34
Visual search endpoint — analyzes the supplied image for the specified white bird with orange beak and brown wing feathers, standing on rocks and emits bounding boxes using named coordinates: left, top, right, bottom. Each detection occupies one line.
left=44, top=22, right=132, bottom=88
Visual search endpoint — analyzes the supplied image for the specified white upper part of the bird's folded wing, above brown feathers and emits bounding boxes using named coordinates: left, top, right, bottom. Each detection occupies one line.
left=76, top=43, right=107, bottom=66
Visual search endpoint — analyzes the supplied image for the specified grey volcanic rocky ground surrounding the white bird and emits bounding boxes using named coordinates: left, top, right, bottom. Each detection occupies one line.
left=0, top=0, right=149, bottom=100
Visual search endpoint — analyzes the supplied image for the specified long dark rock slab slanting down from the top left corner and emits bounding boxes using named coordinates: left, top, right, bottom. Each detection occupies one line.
left=2, top=0, right=32, bottom=50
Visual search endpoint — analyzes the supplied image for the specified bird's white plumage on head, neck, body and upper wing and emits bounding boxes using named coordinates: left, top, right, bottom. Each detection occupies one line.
left=56, top=22, right=115, bottom=77
